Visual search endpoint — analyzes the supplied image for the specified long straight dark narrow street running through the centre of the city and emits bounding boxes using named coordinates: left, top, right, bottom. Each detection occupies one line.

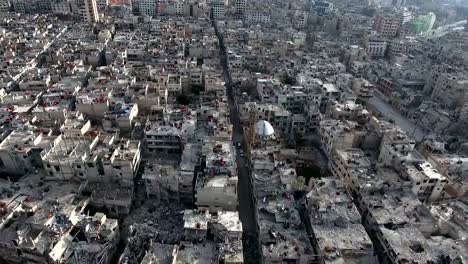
left=213, top=21, right=260, bottom=264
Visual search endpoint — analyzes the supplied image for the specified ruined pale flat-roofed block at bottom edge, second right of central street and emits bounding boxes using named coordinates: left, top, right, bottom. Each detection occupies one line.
left=306, top=179, right=377, bottom=264
